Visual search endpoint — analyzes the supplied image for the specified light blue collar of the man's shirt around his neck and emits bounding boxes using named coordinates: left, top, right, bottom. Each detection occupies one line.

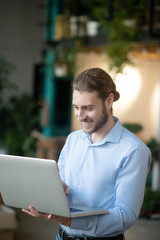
left=82, top=117, right=123, bottom=146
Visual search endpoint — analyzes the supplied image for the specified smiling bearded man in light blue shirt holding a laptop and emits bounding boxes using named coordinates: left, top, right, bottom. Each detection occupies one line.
left=24, top=68, right=151, bottom=240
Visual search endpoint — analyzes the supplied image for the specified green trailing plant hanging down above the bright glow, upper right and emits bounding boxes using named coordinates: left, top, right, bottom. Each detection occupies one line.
left=87, top=0, right=149, bottom=73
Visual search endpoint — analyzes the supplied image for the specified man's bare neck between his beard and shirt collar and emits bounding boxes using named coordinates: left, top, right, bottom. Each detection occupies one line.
left=91, top=115, right=116, bottom=143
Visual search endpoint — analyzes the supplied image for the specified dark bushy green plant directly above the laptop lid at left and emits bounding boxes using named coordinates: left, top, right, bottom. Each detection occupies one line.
left=0, top=94, right=39, bottom=156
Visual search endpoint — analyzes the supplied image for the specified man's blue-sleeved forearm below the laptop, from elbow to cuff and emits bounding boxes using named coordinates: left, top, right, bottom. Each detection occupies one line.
left=71, top=204, right=137, bottom=236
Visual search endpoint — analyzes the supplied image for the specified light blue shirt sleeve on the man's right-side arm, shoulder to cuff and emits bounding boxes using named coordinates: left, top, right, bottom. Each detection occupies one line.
left=70, top=145, right=151, bottom=236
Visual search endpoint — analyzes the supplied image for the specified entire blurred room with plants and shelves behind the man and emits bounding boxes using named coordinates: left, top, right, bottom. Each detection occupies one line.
left=0, top=0, right=160, bottom=240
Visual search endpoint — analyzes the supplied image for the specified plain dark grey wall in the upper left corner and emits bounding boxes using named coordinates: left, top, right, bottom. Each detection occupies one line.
left=0, top=0, right=44, bottom=94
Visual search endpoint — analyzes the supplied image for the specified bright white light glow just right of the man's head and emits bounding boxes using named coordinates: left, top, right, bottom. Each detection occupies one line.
left=114, top=66, right=142, bottom=115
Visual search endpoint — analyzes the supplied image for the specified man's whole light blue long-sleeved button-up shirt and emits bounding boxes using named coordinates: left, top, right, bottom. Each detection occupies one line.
left=58, top=118, right=151, bottom=237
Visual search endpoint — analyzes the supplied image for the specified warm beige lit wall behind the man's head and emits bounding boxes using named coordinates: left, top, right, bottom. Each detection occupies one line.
left=72, top=52, right=160, bottom=141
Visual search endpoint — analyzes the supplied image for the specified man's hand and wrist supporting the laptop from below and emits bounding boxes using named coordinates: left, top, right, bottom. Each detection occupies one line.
left=22, top=206, right=72, bottom=226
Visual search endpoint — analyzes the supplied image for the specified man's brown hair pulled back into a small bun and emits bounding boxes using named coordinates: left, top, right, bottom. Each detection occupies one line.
left=72, top=68, right=120, bottom=101
